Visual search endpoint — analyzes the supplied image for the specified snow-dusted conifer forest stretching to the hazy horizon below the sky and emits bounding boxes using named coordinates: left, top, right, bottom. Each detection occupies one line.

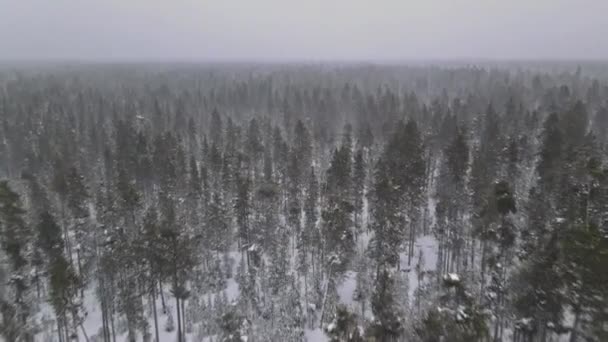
left=0, top=62, right=608, bottom=342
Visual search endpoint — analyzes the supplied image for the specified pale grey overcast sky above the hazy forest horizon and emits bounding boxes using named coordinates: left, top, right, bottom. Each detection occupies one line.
left=0, top=0, right=608, bottom=60
